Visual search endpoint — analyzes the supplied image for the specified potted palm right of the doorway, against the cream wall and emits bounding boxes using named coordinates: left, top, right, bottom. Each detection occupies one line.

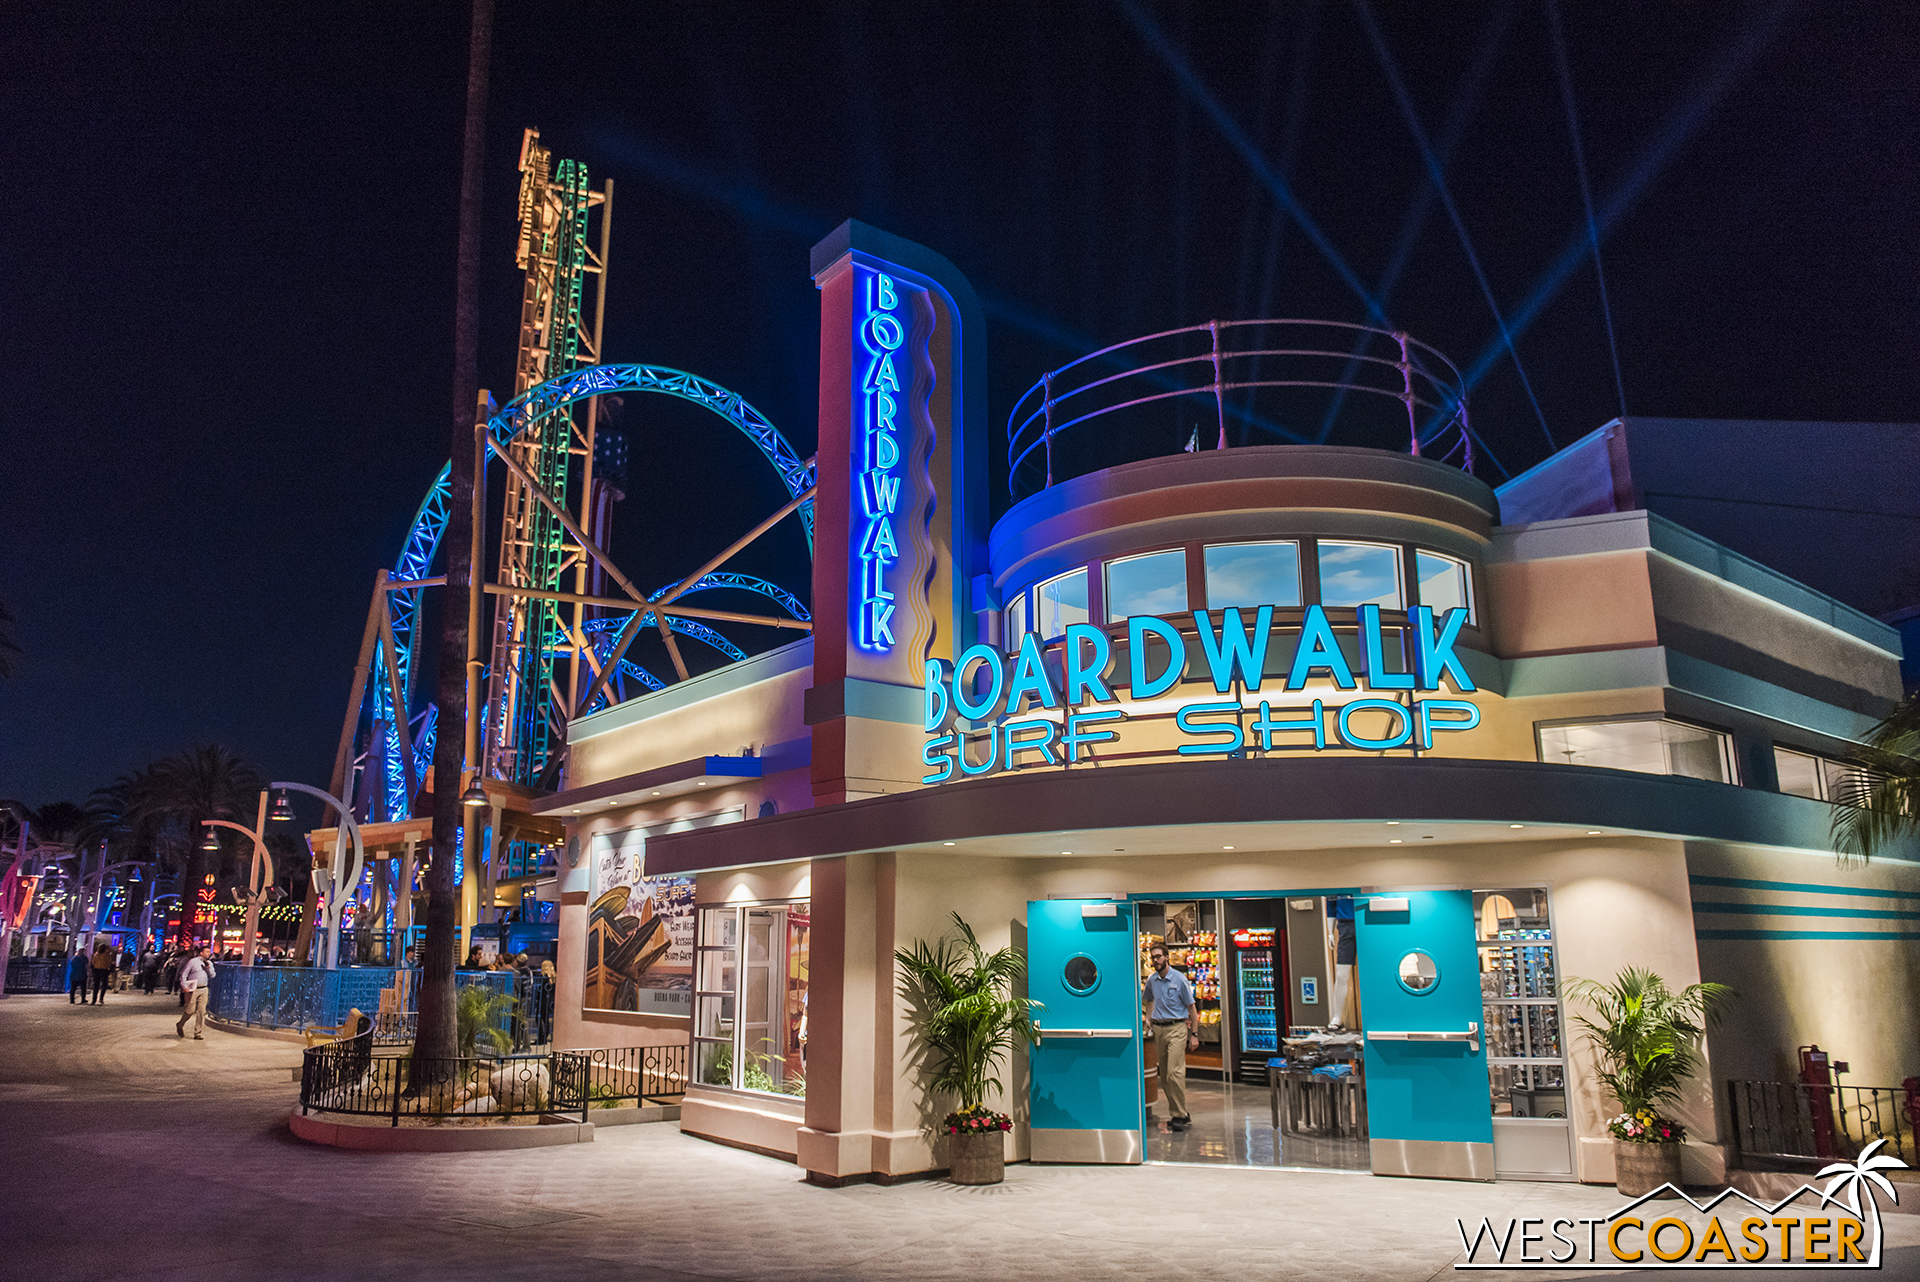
left=1567, top=965, right=1734, bottom=1198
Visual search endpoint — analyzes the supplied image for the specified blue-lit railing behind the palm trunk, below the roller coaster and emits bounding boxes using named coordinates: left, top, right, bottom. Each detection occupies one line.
left=207, top=965, right=553, bottom=1046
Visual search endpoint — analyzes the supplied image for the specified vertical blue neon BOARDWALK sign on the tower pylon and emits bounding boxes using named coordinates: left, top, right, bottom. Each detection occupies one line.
left=854, top=273, right=910, bottom=654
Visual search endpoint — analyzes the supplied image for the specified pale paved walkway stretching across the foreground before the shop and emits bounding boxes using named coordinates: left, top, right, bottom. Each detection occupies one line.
left=0, top=994, right=1920, bottom=1282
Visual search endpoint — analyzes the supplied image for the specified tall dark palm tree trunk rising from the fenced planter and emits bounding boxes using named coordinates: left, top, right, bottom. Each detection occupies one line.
left=409, top=0, right=493, bottom=1090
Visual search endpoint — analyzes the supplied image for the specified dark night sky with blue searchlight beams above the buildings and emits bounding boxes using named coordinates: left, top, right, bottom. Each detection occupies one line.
left=0, top=0, right=1920, bottom=804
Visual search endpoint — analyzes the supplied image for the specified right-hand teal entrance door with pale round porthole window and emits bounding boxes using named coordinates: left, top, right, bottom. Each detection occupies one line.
left=1354, top=890, right=1494, bottom=1180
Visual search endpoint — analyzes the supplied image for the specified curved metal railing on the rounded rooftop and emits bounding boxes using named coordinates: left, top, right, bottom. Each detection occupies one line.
left=1006, top=317, right=1473, bottom=499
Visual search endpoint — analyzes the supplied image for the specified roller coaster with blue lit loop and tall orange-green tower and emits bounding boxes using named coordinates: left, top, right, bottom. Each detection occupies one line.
left=332, top=129, right=814, bottom=935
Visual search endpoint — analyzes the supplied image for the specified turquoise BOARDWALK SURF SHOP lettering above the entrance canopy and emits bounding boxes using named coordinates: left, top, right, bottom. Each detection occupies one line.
left=922, top=605, right=1480, bottom=783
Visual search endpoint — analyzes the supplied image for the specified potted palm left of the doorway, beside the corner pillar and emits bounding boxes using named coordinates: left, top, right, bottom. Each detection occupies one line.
left=893, top=914, right=1041, bottom=1184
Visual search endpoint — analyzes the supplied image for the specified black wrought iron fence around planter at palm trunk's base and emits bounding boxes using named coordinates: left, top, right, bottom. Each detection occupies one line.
left=300, top=1031, right=588, bottom=1127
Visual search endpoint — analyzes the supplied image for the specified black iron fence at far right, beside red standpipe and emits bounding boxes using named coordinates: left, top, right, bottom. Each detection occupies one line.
left=1728, top=1079, right=1920, bottom=1163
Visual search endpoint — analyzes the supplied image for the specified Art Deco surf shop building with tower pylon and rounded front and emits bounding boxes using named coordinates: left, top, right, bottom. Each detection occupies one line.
left=540, top=223, right=1920, bottom=1184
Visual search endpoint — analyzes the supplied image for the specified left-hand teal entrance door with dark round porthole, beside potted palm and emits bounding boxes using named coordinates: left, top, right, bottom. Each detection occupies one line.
left=1027, top=900, right=1146, bottom=1163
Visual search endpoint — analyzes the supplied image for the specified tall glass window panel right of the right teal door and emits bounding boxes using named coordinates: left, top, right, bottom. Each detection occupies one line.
left=1473, top=889, right=1567, bottom=1117
